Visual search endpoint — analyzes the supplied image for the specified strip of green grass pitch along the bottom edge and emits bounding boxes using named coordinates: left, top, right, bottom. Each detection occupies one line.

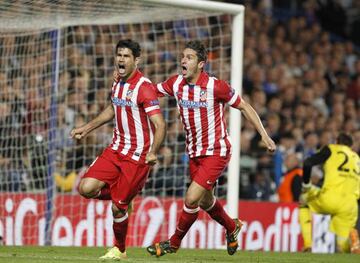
left=0, top=246, right=360, bottom=263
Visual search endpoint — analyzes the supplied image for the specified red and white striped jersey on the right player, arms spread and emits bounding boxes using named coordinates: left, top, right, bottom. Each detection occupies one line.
left=156, top=72, right=241, bottom=158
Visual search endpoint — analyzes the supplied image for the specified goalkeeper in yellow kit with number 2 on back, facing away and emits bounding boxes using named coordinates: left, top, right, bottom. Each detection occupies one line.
left=299, top=133, right=360, bottom=253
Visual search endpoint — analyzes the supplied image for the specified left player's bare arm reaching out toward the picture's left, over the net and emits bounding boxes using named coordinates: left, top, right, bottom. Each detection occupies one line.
left=70, top=105, right=115, bottom=140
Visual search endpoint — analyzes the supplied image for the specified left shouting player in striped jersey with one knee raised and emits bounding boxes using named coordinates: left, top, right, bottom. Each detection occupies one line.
left=71, top=40, right=165, bottom=259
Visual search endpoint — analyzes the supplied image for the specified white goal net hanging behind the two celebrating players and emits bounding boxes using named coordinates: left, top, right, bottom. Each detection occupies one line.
left=0, top=0, right=242, bottom=247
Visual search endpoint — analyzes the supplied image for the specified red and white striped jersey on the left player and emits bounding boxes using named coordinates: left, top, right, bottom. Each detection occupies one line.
left=109, top=70, right=160, bottom=162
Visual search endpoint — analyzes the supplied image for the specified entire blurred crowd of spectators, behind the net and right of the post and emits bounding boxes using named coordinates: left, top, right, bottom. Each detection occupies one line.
left=0, top=1, right=360, bottom=201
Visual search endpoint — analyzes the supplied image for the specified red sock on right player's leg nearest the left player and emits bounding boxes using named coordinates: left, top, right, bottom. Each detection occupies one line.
left=170, top=204, right=200, bottom=248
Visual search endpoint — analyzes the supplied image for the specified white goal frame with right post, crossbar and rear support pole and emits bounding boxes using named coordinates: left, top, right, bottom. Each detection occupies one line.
left=0, top=0, right=245, bottom=245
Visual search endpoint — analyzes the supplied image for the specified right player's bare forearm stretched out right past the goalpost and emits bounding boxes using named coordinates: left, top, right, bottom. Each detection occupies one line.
left=235, top=99, right=276, bottom=152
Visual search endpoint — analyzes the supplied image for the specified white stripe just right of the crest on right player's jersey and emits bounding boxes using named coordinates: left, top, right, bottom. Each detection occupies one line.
left=206, top=78, right=215, bottom=155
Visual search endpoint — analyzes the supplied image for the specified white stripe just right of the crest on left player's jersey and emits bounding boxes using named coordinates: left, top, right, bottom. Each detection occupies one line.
left=131, top=77, right=145, bottom=161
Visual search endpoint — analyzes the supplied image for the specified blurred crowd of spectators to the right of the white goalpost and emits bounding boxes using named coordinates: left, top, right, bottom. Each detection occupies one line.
left=241, top=1, right=360, bottom=200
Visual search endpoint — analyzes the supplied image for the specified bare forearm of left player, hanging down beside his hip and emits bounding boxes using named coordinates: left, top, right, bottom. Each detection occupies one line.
left=145, top=113, right=165, bottom=165
